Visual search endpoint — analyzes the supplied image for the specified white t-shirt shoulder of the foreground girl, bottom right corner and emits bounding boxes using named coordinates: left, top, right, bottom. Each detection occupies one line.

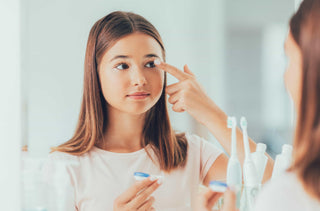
left=253, top=173, right=320, bottom=211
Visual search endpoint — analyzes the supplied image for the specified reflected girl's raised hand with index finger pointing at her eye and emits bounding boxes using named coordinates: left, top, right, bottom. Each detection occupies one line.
left=155, top=60, right=215, bottom=124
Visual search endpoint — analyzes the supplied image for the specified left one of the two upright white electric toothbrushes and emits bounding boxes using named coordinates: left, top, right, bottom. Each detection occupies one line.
left=227, top=117, right=242, bottom=208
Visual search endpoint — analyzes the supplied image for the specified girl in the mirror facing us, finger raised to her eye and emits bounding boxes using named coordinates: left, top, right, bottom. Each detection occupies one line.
left=46, top=12, right=272, bottom=211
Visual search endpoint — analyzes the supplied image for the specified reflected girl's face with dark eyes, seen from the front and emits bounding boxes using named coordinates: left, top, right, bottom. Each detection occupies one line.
left=98, top=33, right=164, bottom=114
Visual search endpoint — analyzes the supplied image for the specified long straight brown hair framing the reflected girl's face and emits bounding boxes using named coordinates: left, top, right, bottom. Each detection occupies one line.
left=52, top=11, right=188, bottom=171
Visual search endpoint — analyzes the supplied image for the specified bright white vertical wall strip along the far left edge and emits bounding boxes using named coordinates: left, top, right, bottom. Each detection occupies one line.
left=0, top=0, right=21, bottom=211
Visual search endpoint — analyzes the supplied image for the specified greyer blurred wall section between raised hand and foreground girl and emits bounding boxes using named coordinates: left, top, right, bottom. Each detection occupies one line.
left=224, top=0, right=294, bottom=155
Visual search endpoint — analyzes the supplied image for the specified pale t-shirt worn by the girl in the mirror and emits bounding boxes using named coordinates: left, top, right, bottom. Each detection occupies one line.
left=44, top=134, right=222, bottom=211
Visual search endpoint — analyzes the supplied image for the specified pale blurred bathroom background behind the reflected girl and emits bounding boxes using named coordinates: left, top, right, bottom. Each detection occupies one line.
left=0, top=0, right=300, bottom=210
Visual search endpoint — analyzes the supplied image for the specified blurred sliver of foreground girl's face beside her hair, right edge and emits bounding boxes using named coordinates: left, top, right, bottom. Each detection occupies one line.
left=284, top=33, right=303, bottom=109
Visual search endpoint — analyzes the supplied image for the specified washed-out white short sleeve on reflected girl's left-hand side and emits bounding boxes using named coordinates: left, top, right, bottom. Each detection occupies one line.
left=42, top=152, right=79, bottom=211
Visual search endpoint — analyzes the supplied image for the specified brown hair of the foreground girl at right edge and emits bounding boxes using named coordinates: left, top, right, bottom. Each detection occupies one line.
left=290, top=0, right=320, bottom=200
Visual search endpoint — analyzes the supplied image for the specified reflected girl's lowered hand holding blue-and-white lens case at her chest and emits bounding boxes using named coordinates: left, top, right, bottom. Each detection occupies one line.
left=113, top=177, right=161, bottom=211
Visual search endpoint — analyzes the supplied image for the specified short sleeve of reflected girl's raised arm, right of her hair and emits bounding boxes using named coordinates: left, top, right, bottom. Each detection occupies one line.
left=186, top=134, right=223, bottom=182
